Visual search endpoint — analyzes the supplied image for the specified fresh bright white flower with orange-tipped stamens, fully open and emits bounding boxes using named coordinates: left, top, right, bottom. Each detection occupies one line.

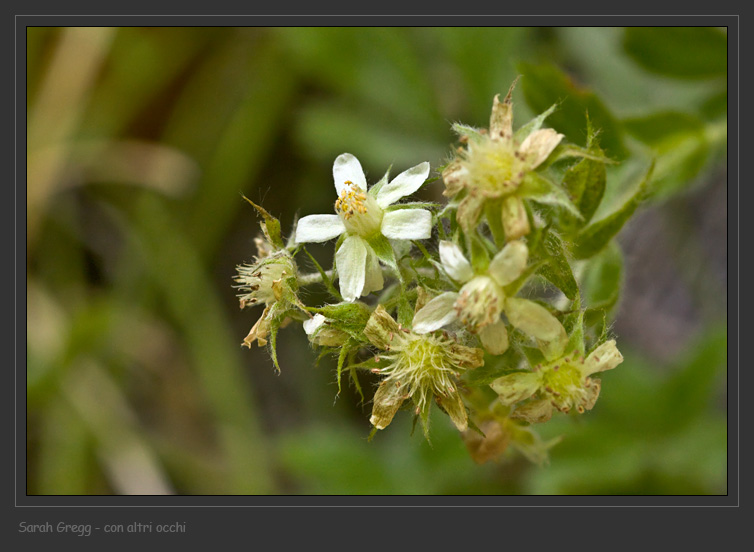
left=296, top=153, right=432, bottom=301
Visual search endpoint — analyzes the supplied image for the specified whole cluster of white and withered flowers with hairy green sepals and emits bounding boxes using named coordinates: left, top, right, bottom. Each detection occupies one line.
left=236, top=77, right=623, bottom=462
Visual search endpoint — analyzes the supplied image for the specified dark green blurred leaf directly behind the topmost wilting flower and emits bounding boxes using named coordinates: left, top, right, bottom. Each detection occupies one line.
left=518, top=63, right=627, bottom=158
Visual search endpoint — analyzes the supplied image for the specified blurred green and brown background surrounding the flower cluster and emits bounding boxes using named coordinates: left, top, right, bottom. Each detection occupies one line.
left=26, top=27, right=727, bottom=495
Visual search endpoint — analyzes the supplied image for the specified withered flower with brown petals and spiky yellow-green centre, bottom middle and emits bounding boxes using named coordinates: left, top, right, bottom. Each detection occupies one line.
left=364, top=305, right=484, bottom=431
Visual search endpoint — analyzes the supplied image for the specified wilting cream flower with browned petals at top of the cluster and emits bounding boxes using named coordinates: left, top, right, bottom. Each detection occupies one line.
left=442, top=83, right=563, bottom=240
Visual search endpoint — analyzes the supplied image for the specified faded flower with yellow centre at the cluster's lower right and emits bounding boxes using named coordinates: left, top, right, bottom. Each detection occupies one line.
left=490, top=339, right=623, bottom=423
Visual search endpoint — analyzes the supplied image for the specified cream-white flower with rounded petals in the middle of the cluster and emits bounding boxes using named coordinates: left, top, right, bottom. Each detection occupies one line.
left=414, top=240, right=567, bottom=355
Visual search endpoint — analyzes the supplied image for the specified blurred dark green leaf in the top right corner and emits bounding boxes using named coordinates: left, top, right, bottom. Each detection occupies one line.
left=623, top=27, right=728, bottom=79
